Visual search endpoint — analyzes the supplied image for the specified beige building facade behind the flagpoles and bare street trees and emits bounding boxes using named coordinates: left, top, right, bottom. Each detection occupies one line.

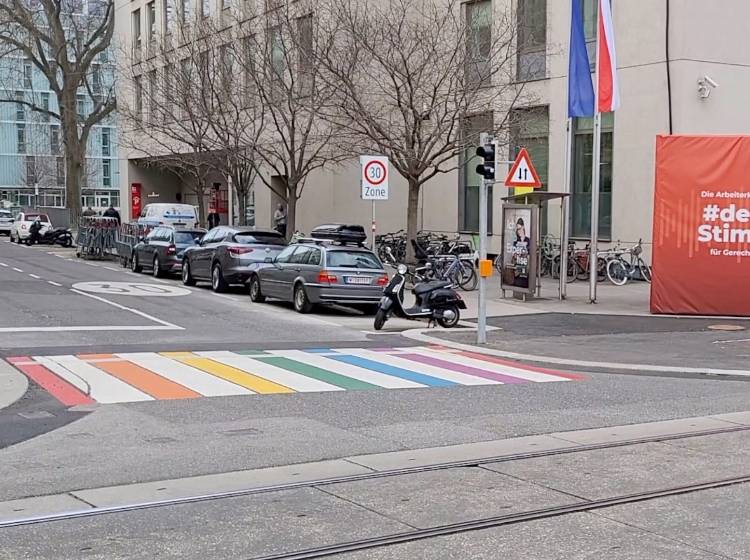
left=117, top=0, right=750, bottom=252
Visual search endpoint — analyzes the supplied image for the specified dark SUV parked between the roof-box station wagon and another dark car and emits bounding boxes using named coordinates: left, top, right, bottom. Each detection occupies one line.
left=182, top=226, right=286, bottom=292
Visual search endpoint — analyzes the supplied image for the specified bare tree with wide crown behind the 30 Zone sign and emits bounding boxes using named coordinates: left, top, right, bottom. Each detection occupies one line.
left=318, top=0, right=521, bottom=259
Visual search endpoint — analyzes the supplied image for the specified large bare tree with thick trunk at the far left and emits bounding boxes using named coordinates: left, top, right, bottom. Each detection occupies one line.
left=0, top=0, right=116, bottom=222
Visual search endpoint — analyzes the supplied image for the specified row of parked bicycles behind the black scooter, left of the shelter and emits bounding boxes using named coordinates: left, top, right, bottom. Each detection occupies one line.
left=375, top=230, right=479, bottom=291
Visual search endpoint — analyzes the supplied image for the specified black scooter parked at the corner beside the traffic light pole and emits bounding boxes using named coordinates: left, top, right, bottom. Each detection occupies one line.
left=374, top=264, right=466, bottom=331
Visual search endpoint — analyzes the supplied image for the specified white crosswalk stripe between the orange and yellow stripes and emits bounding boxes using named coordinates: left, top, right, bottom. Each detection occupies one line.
left=116, top=352, right=253, bottom=397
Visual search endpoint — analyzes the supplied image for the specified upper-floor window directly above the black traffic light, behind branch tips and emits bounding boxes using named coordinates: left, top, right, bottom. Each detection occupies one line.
left=466, top=0, right=492, bottom=86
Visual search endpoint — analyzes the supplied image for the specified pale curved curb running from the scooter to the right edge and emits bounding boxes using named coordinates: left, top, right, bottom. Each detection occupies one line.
left=401, top=328, right=750, bottom=377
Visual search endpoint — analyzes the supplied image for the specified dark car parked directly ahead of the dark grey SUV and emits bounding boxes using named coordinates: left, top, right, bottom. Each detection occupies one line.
left=130, top=226, right=206, bottom=278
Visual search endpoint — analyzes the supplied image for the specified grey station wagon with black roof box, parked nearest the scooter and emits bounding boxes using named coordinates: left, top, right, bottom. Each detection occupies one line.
left=248, top=239, right=388, bottom=314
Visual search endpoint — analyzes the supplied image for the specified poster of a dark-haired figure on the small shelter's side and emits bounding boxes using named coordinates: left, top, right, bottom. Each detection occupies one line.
left=502, top=204, right=537, bottom=293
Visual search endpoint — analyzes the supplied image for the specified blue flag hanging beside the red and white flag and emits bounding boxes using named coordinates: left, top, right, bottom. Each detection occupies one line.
left=568, top=0, right=594, bottom=117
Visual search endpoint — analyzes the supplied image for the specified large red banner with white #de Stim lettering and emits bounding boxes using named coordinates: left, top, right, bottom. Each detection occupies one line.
left=651, top=136, right=750, bottom=316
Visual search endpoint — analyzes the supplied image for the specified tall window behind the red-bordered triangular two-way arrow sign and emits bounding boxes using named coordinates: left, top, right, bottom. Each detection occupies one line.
left=508, top=107, right=549, bottom=234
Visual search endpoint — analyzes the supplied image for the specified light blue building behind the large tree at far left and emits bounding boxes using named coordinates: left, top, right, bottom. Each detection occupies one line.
left=0, top=51, right=120, bottom=209
